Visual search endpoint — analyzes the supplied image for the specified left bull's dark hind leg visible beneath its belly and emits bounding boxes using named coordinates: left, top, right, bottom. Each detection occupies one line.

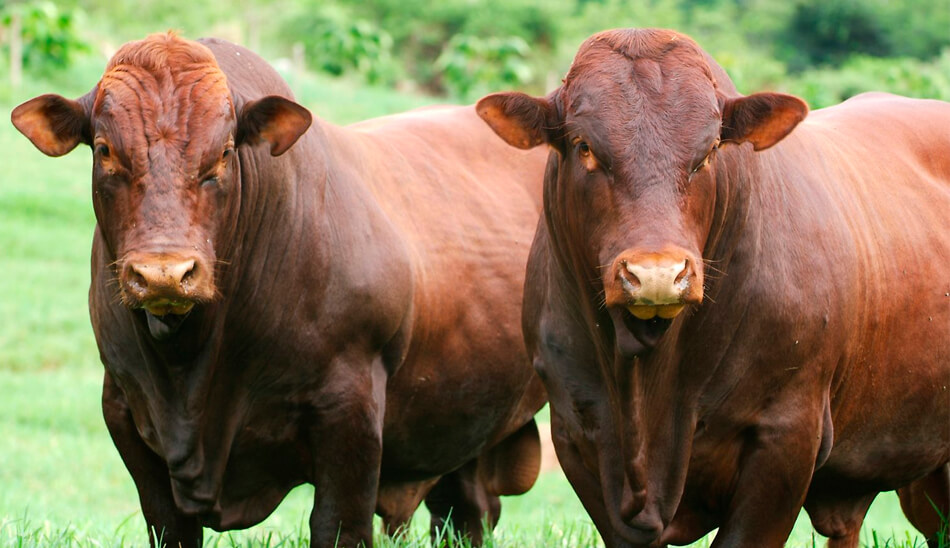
left=425, top=459, right=501, bottom=546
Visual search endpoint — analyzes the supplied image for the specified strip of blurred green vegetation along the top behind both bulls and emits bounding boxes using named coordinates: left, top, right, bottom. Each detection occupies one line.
left=0, top=0, right=950, bottom=108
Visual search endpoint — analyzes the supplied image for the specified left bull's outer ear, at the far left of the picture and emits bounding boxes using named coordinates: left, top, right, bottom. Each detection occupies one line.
left=10, top=94, right=91, bottom=156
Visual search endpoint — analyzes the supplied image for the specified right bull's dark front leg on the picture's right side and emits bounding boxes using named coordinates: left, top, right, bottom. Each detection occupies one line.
left=712, top=414, right=820, bottom=548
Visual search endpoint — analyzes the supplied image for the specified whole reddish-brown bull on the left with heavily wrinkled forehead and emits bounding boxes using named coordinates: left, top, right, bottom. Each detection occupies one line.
left=13, top=34, right=546, bottom=546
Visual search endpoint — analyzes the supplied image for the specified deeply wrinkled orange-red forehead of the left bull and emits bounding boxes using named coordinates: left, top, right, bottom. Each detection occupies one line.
left=93, top=33, right=234, bottom=175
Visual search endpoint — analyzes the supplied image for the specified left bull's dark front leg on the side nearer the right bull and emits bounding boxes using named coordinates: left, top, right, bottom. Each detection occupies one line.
left=309, top=360, right=386, bottom=548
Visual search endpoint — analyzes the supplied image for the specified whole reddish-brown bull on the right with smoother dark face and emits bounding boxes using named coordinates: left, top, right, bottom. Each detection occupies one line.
left=477, top=30, right=950, bottom=547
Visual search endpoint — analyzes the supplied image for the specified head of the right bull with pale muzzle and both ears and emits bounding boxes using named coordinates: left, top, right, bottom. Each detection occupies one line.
left=477, top=35, right=808, bottom=354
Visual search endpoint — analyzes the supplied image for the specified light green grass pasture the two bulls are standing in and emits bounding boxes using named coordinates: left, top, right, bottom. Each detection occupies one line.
left=0, top=65, right=936, bottom=547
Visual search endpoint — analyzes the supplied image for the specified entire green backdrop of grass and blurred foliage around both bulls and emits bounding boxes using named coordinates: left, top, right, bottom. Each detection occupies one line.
left=0, top=0, right=950, bottom=546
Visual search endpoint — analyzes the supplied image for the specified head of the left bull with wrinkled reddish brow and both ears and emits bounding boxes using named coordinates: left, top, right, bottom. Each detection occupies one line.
left=12, top=34, right=311, bottom=339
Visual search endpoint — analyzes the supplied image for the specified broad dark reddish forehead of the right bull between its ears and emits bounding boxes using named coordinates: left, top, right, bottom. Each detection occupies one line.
left=558, top=29, right=721, bottom=177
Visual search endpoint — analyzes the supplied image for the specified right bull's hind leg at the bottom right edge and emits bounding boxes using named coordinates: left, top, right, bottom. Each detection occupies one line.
left=897, top=463, right=950, bottom=548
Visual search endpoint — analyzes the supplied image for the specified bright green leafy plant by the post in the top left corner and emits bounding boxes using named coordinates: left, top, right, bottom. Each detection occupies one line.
left=0, top=2, right=90, bottom=73
